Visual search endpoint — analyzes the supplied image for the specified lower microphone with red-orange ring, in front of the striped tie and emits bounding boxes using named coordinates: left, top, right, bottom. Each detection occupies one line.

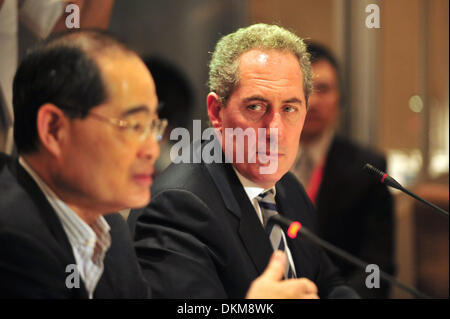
left=267, top=214, right=431, bottom=299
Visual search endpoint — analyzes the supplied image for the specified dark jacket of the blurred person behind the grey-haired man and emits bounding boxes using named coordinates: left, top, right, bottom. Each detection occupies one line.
left=316, top=137, right=394, bottom=298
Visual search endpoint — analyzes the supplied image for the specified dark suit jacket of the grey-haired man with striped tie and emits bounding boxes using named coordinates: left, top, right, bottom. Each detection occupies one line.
left=128, top=141, right=356, bottom=298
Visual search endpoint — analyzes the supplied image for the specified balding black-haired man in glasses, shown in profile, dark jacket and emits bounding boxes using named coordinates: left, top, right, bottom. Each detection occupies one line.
left=0, top=31, right=163, bottom=298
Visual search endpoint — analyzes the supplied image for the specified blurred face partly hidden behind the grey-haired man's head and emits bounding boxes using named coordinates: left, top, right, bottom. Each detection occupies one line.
left=301, top=60, right=340, bottom=143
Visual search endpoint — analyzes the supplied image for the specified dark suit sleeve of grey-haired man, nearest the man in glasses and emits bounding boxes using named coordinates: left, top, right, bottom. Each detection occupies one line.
left=135, top=190, right=227, bottom=298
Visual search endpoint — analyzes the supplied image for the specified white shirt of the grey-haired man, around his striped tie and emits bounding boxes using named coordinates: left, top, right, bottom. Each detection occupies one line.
left=233, top=166, right=297, bottom=276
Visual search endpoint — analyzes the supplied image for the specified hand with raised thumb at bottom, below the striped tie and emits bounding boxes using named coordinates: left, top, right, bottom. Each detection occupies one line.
left=246, top=251, right=319, bottom=299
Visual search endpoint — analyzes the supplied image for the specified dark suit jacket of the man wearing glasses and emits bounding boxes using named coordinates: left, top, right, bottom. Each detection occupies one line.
left=0, top=155, right=149, bottom=298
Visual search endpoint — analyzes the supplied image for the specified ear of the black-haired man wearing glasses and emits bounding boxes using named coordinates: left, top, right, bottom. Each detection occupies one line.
left=37, top=103, right=68, bottom=157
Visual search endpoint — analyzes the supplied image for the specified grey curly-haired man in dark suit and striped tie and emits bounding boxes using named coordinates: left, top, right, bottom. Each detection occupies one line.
left=129, top=24, right=357, bottom=298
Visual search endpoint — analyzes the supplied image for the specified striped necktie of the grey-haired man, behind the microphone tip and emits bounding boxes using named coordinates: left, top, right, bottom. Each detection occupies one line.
left=257, top=190, right=296, bottom=278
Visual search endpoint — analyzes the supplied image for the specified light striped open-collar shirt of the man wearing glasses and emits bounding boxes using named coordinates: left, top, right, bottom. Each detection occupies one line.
left=19, top=157, right=111, bottom=299
